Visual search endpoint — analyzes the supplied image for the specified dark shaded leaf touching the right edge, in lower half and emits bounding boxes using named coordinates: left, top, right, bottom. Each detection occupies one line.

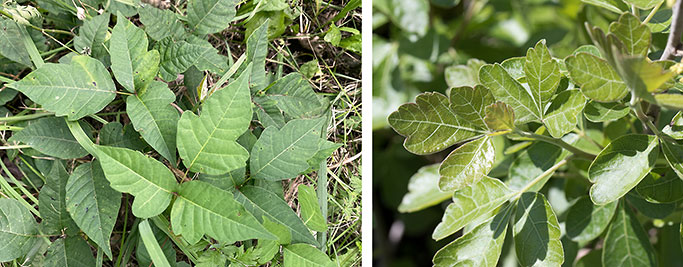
left=636, top=171, right=683, bottom=203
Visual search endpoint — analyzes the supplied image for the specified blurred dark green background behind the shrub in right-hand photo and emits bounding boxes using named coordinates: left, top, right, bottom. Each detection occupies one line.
left=372, top=0, right=682, bottom=266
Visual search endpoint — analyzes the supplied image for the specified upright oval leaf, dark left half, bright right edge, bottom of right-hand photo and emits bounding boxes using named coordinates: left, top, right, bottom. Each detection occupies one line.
left=513, top=192, right=564, bottom=266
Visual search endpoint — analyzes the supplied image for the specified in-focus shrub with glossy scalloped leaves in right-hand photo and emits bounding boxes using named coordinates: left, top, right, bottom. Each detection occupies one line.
left=390, top=0, right=683, bottom=266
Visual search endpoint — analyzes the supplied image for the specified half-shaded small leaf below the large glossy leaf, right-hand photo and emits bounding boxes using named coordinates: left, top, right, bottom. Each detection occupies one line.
left=565, top=196, right=617, bottom=244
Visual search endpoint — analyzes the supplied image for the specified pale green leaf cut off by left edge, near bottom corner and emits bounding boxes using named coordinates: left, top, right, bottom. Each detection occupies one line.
left=0, top=197, right=38, bottom=262
